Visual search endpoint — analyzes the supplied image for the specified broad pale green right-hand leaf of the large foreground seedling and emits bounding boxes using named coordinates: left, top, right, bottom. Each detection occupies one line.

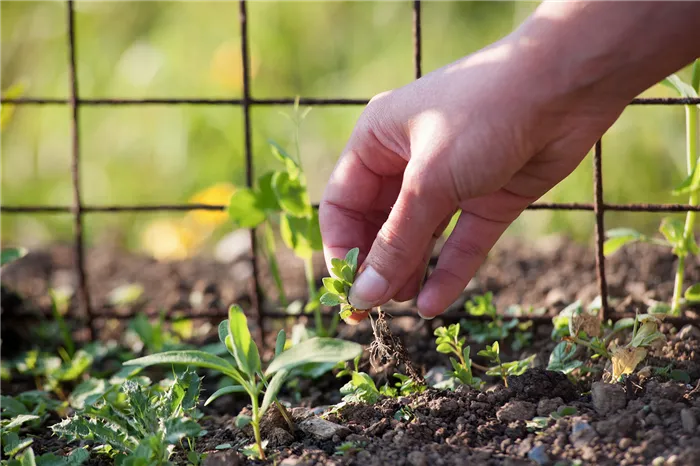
left=265, top=337, right=362, bottom=374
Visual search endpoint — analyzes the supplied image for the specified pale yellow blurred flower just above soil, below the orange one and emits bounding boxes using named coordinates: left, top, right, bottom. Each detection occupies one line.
left=141, top=219, right=201, bottom=260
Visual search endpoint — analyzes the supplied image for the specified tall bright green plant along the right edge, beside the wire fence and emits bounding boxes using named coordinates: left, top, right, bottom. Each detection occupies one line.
left=603, top=59, right=700, bottom=315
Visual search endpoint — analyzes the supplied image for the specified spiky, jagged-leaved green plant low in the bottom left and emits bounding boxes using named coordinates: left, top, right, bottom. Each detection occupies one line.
left=51, top=370, right=201, bottom=466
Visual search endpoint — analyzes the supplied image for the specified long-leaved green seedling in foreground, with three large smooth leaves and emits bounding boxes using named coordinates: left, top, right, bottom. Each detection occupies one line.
left=124, top=305, right=362, bottom=459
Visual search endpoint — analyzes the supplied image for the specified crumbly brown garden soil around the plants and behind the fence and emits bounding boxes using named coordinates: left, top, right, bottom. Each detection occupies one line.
left=0, top=240, right=700, bottom=466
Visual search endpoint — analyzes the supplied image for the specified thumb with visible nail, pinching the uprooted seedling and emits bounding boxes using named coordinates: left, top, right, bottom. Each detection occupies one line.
left=348, top=169, right=453, bottom=310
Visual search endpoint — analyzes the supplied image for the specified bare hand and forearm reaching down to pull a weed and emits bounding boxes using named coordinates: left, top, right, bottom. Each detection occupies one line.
left=319, top=0, right=700, bottom=322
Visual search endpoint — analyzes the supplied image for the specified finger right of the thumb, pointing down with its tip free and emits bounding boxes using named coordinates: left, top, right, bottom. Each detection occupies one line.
left=417, top=211, right=510, bottom=319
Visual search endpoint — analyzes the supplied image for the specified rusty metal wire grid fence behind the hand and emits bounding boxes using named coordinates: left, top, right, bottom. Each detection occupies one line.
left=0, top=0, right=700, bottom=340
